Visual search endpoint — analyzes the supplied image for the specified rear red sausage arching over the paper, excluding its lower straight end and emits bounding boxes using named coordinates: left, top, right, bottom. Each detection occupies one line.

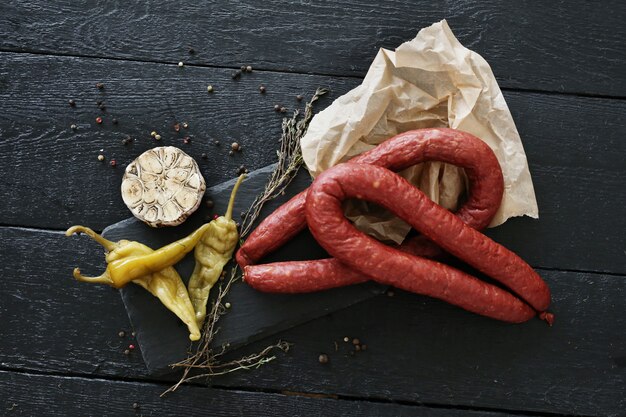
left=236, top=128, right=504, bottom=268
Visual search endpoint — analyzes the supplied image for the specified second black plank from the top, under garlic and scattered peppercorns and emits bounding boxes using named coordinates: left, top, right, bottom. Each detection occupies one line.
left=0, top=54, right=626, bottom=273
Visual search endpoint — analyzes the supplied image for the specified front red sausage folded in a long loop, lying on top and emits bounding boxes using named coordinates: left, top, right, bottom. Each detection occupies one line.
left=305, top=163, right=550, bottom=314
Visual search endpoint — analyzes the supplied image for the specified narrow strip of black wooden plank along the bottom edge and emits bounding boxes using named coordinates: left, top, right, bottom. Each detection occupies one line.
left=0, top=371, right=520, bottom=417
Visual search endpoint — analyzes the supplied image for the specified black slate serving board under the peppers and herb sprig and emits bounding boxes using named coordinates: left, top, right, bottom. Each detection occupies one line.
left=103, top=165, right=384, bottom=374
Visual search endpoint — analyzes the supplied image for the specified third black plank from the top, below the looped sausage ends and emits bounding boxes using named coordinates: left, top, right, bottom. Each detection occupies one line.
left=0, top=228, right=626, bottom=415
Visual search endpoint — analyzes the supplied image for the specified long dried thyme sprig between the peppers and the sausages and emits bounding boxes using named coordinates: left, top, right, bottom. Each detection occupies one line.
left=161, top=88, right=328, bottom=396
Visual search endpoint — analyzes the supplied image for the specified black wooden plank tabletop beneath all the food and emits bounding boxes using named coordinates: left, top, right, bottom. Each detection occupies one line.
left=0, top=0, right=626, bottom=417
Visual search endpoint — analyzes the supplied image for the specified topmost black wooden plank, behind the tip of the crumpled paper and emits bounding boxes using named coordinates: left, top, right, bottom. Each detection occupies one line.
left=0, top=0, right=626, bottom=97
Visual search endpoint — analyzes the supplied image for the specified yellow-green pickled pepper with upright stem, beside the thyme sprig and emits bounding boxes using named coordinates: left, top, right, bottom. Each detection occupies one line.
left=187, top=175, right=246, bottom=327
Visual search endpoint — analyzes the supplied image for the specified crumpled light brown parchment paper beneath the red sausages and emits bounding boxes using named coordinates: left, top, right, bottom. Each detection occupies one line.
left=301, top=20, right=538, bottom=243
